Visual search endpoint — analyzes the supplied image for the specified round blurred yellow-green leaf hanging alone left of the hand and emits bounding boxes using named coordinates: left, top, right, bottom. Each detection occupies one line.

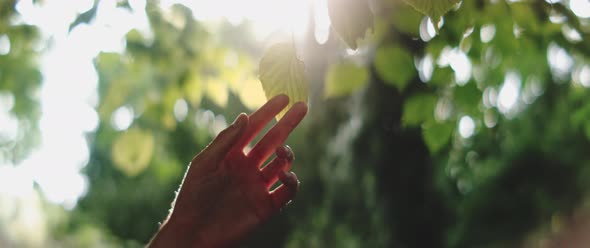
left=111, top=128, right=155, bottom=177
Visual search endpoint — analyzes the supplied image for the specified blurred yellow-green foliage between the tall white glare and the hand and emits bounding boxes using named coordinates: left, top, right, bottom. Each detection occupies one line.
left=77, top=3, right=272, bottom=242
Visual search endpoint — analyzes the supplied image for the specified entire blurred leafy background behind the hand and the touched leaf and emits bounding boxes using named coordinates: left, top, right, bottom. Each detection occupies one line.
left=0, top=0, right=590, bottom=247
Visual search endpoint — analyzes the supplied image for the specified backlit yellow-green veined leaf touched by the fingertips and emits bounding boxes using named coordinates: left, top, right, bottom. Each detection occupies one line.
left=260, top=42, right=308, bottom=119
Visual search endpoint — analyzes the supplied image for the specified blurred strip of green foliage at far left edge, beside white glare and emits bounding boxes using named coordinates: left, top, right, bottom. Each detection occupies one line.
left=0, top=1, right=41, bottom=163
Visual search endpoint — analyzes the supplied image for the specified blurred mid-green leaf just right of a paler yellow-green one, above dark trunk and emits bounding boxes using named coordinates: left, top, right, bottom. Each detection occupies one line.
left=375, top=45, right=416, bottom=91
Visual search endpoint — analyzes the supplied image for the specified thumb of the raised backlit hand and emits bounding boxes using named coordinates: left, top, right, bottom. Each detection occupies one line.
left=203, top=113, right=248, bottom=160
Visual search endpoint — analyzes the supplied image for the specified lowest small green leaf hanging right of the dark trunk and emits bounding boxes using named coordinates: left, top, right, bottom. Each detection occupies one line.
left=422, top=121, right=455, bottom=154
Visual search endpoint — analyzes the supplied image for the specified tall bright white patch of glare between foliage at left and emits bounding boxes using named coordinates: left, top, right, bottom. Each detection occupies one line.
left=10, top=0, right=139, bottom=209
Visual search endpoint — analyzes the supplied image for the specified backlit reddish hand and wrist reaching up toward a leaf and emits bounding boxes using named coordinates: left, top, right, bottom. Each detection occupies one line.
left=148, top=95, right=307, bottom=247
